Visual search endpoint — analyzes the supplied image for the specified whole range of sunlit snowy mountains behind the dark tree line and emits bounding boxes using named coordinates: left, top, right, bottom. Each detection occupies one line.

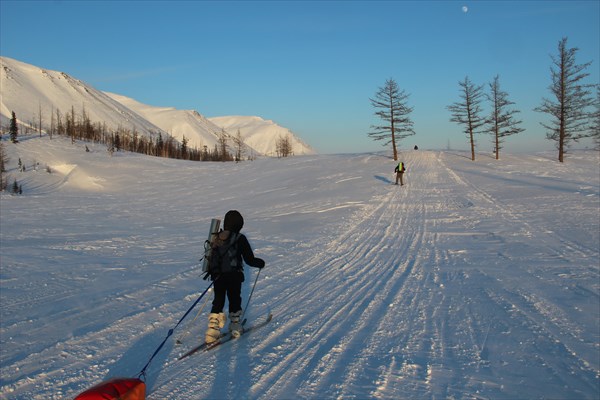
left=0, top=57, right=316, bottom=155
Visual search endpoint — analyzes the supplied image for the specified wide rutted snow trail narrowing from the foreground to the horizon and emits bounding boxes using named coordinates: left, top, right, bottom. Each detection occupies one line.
left=155, top=153, right=598, bottom=399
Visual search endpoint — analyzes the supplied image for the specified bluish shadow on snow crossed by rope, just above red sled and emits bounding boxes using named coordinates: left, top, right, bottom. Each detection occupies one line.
left=104, top=330, right=173, bottom=393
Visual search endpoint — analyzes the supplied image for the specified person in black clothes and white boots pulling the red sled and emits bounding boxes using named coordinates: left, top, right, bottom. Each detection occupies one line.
left=205, top=210, right=265, bottom=344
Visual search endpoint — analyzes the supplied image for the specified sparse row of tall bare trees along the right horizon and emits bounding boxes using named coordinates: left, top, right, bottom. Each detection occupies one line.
left=368, top=38, right=600, bottom=162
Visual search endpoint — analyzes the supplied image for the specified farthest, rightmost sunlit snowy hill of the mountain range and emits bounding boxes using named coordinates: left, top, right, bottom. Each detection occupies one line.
left=209, top=116, right=316, bottom=155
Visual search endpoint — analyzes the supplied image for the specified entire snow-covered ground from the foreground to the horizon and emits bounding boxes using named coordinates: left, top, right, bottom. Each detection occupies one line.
left=0, top=137, right=600, bottom=399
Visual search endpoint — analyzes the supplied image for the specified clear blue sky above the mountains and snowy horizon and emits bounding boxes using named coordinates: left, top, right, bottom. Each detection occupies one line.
left=0, top=0, right=600, bottom=153
